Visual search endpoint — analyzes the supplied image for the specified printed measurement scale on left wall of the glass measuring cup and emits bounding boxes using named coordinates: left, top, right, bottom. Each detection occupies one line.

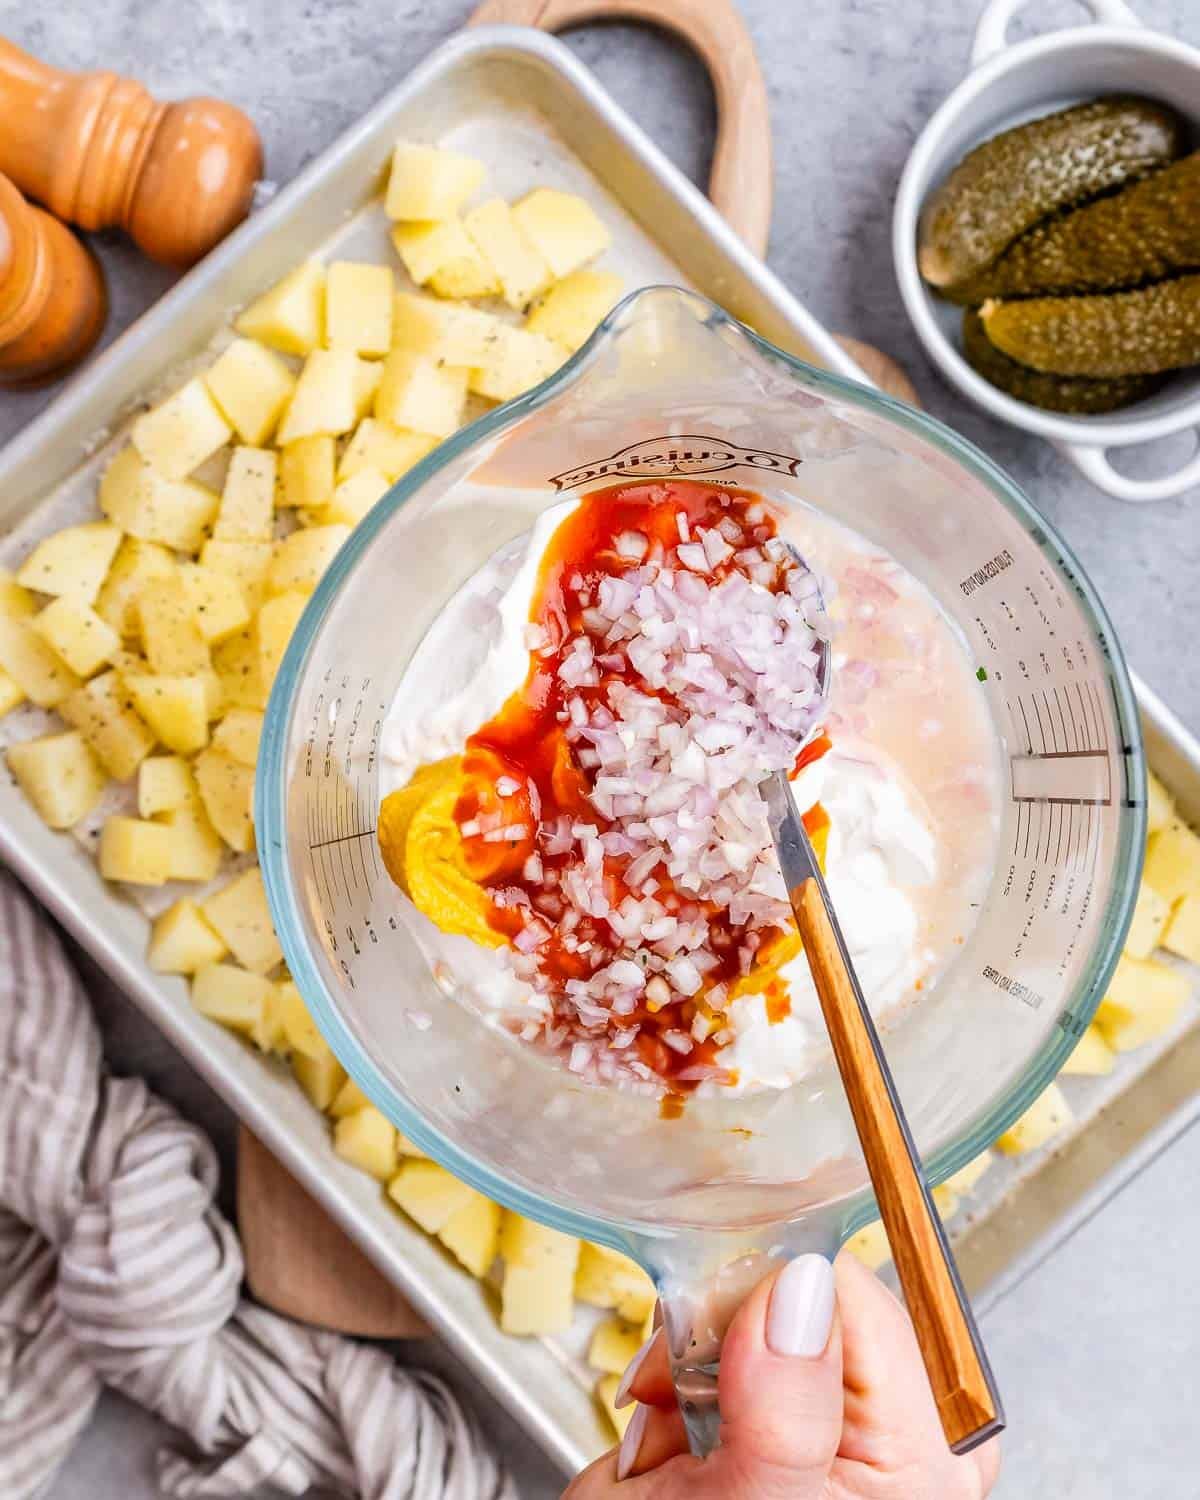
left=305, top=669, right=395, bottom=986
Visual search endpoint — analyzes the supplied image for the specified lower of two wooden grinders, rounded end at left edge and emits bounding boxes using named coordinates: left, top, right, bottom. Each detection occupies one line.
left=0, top=177, right=108, bottom=386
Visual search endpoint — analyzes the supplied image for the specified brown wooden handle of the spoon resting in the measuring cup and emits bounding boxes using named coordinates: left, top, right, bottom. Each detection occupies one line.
left=791, top=879, right=1004, bottom=1454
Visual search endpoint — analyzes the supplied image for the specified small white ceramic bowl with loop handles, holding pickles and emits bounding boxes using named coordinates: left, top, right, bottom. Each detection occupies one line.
left=893, top=0, right=1200, bottom=501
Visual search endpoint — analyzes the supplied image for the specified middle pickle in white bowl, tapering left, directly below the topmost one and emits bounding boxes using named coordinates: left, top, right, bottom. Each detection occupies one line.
left=944, top=152, right=1200, bottom=305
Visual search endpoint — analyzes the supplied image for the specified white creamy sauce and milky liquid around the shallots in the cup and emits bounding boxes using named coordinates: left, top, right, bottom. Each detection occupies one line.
left=380, top=501, right=999, bottom=1097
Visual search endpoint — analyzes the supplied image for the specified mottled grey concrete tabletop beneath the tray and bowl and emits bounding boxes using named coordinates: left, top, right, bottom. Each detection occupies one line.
left=0, top=0, right=1200, bottom=1500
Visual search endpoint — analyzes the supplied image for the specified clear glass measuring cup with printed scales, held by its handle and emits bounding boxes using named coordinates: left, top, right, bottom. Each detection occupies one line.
left=257, top=288, right=1146, bottom=1448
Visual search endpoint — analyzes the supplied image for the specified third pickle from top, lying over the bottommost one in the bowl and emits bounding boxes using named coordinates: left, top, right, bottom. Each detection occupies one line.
left=980, top=276, right=1200, bottom=380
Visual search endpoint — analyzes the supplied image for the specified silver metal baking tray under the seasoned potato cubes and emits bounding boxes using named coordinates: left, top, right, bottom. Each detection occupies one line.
left=0, top=27, right=1200, bottom=1472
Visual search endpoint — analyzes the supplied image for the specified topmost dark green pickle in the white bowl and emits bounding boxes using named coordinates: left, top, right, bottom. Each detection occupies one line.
left=917, top=96, right=1187, bottom=287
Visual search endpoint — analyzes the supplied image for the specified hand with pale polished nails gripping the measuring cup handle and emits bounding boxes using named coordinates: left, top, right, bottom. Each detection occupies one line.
left=563, top=1254, right=1001, bottom=1500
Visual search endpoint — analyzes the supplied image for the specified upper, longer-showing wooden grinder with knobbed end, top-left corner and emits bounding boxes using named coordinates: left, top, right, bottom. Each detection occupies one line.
left=0, top=39, right=263, bottom=267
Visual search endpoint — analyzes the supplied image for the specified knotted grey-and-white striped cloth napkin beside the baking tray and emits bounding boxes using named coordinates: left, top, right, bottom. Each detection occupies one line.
left=0, top=870, right=516, bottom=1500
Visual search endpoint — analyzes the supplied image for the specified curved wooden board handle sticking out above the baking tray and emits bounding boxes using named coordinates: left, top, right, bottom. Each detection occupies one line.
left=467, top=0, right=773, bottom=257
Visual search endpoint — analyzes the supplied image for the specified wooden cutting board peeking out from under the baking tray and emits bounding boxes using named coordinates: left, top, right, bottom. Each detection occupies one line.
left=237, top=0, right=920, bottom=1338
